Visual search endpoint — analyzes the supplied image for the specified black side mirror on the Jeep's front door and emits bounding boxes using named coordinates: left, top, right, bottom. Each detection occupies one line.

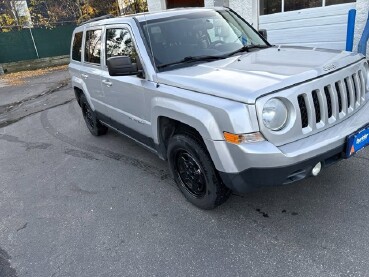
left=106, top=56, right=138, bottom=76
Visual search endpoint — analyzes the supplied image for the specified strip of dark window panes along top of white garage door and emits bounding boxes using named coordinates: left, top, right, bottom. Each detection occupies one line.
left=260, top=0, right=355, bottom=15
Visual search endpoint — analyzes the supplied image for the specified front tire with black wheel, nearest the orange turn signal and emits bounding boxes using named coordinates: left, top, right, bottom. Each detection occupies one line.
left=167, top=134, right=231, bottom=210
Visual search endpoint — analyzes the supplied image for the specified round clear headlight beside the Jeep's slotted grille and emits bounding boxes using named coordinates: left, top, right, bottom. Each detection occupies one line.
left=262, top=98, right=288, bottom=131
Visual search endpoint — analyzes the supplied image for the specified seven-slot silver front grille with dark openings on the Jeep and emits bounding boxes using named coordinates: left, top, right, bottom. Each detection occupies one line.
left=297, top=70, right=365, bottom=133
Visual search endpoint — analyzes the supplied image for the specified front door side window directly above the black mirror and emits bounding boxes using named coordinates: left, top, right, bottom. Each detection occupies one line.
left=106, top=28, right=137, bottom=63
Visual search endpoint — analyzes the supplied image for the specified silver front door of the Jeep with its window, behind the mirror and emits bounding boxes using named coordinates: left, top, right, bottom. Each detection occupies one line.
left=101, top=24, right=151, bottom=146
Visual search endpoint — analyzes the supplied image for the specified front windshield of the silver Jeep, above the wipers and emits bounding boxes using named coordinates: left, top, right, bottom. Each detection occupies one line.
left=141, top=10, right=268, bottom=70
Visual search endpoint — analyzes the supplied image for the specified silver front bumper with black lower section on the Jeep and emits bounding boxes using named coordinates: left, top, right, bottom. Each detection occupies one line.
left=210, top=103, right=369, bottom=192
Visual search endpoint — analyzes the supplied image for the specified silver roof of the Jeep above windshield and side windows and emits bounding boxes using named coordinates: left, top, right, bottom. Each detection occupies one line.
left=78, top=7, right=227, bottom=29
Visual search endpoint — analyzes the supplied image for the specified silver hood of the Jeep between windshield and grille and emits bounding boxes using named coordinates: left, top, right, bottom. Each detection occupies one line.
left=156, top=46, right=362, bottom=104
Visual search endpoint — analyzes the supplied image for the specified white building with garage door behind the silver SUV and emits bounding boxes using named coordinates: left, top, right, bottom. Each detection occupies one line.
left=147, top=0, right=369, bottom=53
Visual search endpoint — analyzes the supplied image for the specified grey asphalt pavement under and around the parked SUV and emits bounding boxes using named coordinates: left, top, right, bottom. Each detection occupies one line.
left=0, top=68, right=369, bottom=277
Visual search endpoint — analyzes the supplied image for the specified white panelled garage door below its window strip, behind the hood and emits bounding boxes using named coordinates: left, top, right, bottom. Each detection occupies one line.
left=259, top=3, right=356, bottom=50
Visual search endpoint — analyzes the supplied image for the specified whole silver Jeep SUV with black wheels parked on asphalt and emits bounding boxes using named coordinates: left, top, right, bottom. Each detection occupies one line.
left=69, top=8, right=369, bottom=209
